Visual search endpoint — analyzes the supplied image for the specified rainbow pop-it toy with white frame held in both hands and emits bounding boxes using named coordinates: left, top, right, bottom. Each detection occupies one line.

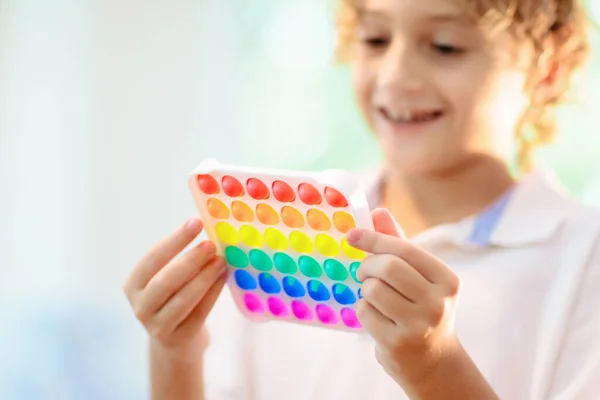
left=189, top=160, right=373, bottom=332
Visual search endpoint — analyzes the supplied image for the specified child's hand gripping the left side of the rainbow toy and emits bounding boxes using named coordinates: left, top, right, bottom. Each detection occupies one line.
left=124, top=219, right=227, bottom=360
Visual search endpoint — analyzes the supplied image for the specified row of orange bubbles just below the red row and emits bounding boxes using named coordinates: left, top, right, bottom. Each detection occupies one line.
left=206, top=198, right=356, bottom=233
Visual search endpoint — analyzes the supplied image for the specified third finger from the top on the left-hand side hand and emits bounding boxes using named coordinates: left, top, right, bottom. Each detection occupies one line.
left=153, top=258, right=225, bottom=333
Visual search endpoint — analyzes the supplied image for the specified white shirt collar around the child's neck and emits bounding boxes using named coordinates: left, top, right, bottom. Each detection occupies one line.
left=359, top=166, right=576, bottom=249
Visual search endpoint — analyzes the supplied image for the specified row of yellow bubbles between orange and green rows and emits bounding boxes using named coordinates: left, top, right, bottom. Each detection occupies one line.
left=215, top=222, right=366, bottom=260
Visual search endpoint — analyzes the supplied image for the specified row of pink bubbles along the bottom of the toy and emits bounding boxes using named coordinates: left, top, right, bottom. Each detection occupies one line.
left=244, top=293, right=362, bottom=329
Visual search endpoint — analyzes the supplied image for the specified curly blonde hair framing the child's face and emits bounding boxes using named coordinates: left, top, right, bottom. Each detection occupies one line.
left=336, top=0, right=589, bottom=171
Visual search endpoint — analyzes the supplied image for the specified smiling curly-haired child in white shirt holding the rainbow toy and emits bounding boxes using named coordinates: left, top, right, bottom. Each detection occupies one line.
left=125, top=0, right=600, bottom=400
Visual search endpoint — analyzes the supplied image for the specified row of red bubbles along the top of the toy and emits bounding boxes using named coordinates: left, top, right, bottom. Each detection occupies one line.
left=198, top=175, right=348, bottom=207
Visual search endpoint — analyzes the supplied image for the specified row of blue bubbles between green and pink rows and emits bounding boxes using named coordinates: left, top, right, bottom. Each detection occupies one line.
left=234, top=269, right=362, bottom=305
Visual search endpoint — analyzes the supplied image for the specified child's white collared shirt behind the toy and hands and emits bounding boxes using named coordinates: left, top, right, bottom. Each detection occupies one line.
left=205, top=173, right=600, bottom=400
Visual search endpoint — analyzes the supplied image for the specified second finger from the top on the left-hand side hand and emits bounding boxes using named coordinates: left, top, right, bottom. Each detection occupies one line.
left=136, top=241, right=216, bottom=315
